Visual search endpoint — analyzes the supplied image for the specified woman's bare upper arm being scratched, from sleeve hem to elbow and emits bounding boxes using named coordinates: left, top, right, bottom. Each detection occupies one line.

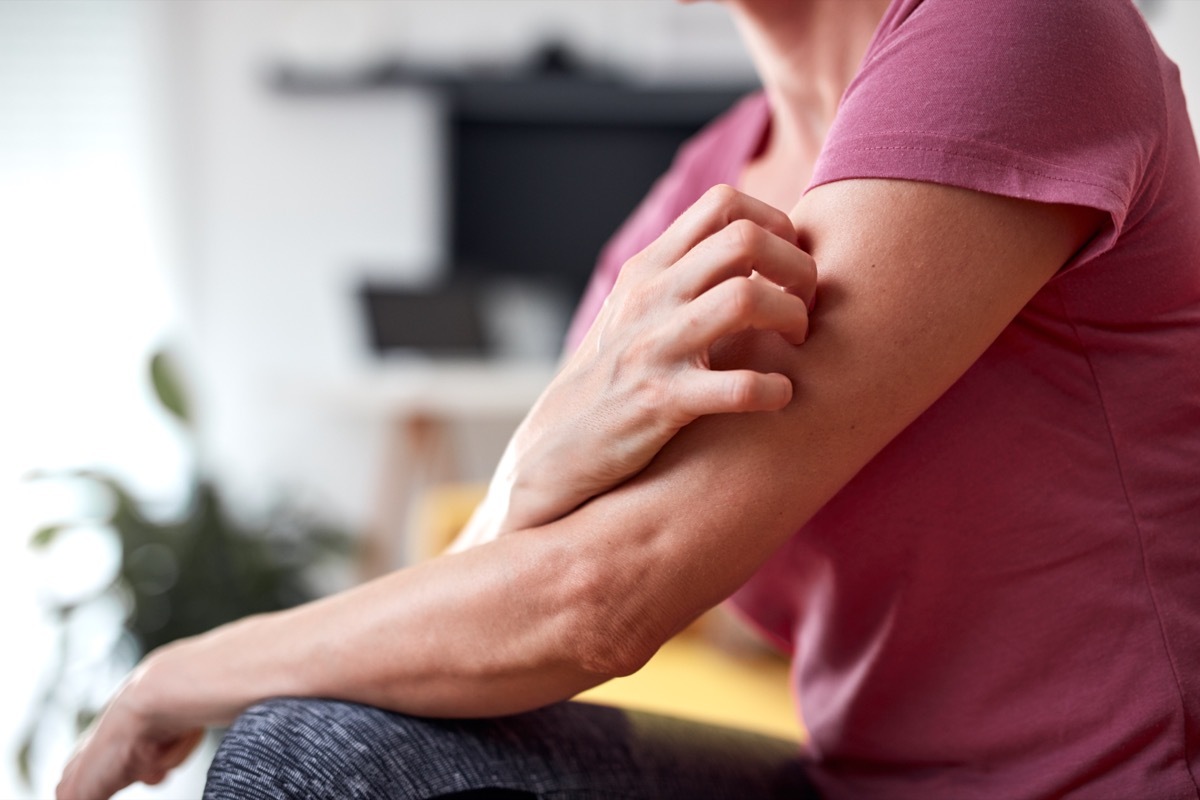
left=554, top=180, right=1102, bottom=673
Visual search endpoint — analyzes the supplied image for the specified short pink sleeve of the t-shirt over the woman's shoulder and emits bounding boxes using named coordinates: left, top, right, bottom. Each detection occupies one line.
left=810, top=0, right=1165, bottom=255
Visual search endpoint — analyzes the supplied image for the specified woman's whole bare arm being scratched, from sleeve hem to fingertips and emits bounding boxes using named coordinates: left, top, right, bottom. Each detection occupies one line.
left=60, top=180, right=1102, bottom=798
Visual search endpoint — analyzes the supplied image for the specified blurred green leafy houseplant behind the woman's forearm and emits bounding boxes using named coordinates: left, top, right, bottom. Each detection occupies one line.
left=17, top=351, right=352, bottom=784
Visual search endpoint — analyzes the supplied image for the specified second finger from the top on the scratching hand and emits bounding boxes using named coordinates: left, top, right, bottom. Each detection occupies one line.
left=664, top=221, right=817, bottom=306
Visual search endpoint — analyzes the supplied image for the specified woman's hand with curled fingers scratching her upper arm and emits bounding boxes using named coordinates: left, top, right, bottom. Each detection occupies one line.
left=458, top=186, right=816, bottom=547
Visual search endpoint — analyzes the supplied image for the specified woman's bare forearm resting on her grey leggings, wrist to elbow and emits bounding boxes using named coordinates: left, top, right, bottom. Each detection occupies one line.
left=134, top=530, right=612, bottom=726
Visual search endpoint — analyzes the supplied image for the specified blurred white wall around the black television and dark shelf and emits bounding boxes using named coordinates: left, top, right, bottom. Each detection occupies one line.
left=171, top=0, right=751, bottom=534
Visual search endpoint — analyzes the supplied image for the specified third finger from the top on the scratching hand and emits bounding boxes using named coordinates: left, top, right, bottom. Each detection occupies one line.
left=672, top=277, right=809, bottom=354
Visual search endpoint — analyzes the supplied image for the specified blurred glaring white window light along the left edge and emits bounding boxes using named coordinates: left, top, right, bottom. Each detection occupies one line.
left=0, top=0, right=186, bottom=796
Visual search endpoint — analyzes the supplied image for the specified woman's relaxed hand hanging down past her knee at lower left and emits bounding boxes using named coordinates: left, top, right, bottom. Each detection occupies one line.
left=56, top=657, right=204, bottom=800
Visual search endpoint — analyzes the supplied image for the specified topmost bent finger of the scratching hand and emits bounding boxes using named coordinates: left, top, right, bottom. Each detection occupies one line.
left=636, top=184, right=796, bottom=269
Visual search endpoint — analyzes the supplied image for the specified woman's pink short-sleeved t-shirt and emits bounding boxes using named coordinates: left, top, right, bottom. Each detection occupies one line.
left=571, top=0, right=1200, bottom=799
